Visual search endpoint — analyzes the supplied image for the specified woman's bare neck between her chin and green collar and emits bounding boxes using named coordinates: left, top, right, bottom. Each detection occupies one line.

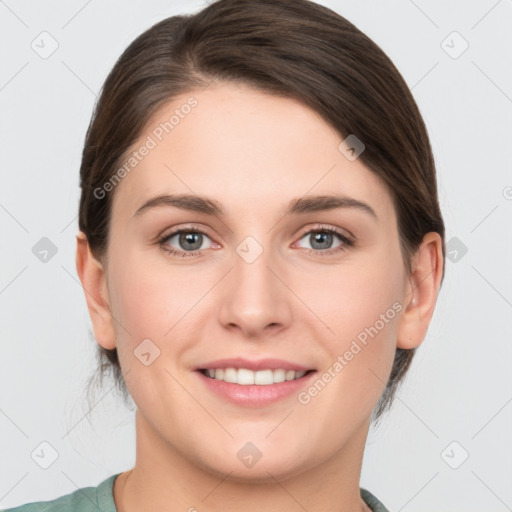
left=114, top=410, right=370, bottom=512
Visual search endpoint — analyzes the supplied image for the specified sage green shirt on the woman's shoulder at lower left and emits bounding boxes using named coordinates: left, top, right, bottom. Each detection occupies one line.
left=1, top=473, right=119, bottom=512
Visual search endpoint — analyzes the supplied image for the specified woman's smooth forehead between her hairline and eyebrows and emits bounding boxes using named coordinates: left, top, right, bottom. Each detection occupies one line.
left=113, top=83, right=393, bottom=222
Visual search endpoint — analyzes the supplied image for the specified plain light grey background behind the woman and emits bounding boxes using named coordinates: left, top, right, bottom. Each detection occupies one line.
left=0, top=0, right=512, bottom=512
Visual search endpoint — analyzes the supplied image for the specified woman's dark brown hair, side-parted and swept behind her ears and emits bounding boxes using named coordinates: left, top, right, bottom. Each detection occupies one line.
left=79, top=0, right=445, bottom=422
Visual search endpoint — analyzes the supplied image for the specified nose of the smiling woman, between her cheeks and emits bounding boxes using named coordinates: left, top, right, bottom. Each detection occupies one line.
left=219, top=242, right=293, bottom=341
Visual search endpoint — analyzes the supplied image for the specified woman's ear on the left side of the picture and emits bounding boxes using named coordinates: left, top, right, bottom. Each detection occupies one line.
left=76, top=231, right=116, bottom=349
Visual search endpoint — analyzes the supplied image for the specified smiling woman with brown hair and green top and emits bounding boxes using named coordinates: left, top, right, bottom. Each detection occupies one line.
left=2, top=0, right=444, bottom=512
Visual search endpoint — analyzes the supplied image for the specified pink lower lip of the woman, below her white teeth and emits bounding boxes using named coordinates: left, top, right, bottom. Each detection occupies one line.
left=196, top=371, right=316, bottom=407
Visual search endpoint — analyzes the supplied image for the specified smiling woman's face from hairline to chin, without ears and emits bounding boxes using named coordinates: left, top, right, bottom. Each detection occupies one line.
left=100, top=83, right=410, bottom=479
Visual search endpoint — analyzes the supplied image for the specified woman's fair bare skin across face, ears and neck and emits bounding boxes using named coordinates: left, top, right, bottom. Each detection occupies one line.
left=77, top=83, right=442, bottom=512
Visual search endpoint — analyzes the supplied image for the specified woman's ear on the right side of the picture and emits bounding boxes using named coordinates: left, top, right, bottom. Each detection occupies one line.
left=397, top=232, right=443, bottom=349
